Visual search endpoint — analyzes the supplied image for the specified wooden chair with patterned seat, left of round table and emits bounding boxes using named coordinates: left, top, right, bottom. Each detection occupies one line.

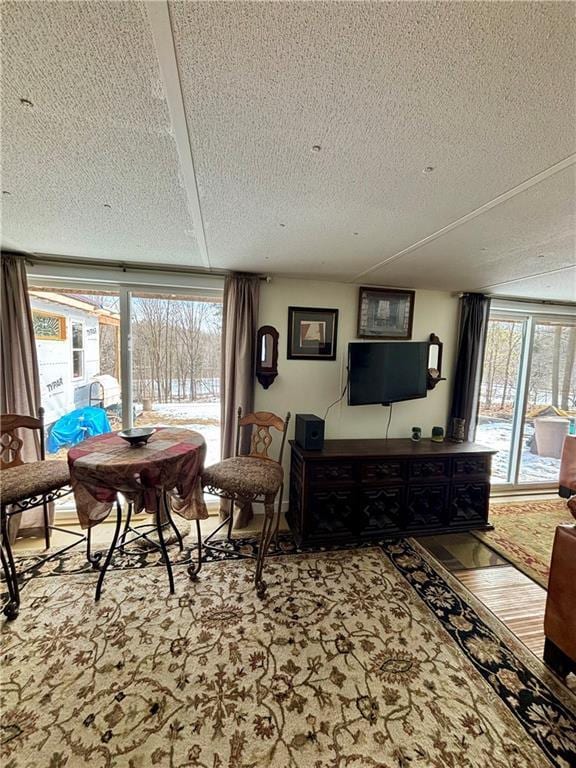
left=0, top=408, right=85, bottom=619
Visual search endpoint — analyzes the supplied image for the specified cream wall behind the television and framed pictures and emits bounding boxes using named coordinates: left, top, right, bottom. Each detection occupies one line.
left=255, top=278, right=458, bottom=480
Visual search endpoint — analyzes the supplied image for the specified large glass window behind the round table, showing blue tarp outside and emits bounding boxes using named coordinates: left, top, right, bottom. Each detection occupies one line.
left=28, top=264, right=223, bottom=512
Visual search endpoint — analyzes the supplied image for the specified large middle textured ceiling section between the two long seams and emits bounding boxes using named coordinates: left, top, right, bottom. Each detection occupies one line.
left=170, top=2, right=575, bottom=288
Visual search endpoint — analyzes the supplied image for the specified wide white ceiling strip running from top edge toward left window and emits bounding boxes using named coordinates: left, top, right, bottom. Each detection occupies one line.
left=146, top=0, right=211, bottom=269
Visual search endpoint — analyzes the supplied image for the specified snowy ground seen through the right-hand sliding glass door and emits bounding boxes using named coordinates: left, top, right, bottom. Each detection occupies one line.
left=476, top=419, right=560, bottom=483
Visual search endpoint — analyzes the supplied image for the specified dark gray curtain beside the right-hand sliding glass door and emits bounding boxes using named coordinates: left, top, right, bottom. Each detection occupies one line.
left=450, top=293, right=490, bottom=441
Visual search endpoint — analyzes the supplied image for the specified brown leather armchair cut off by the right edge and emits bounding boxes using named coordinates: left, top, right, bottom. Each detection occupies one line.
left=544, top=435, right=576, bottom=677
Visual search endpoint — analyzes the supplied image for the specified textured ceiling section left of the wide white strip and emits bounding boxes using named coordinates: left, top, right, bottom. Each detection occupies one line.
left=2, top=0, right=201, bottom=264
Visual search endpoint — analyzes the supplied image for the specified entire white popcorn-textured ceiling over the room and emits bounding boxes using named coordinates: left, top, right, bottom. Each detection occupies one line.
left=2, top=0, right=576, bottom=301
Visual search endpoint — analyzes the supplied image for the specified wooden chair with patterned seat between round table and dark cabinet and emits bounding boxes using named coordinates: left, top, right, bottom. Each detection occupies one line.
left=202, top=408, right=290, bottom=597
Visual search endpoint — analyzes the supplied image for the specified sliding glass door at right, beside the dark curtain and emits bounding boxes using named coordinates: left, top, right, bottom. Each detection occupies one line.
left=476, top=309, right=576, bottom=488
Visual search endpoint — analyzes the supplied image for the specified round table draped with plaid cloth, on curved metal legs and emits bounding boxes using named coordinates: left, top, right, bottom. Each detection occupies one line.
left=68, top=427, right=208, bottom=600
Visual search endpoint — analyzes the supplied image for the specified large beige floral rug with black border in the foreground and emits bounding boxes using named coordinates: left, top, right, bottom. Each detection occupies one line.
left=0, top=540, right=576, bottom=768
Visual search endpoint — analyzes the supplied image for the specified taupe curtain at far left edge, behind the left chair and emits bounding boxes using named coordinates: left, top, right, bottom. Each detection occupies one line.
left=0, top=253, right=43, bottom=539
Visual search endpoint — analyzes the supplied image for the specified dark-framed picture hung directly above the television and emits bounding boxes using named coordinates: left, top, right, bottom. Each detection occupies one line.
left=358, top=288, right=415, bottom=339
